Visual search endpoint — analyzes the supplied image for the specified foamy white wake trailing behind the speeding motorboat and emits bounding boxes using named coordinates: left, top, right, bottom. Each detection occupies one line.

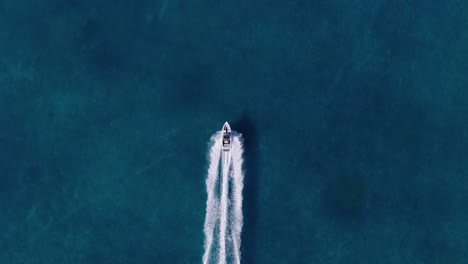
left=203, top=131, right=244, bottom=264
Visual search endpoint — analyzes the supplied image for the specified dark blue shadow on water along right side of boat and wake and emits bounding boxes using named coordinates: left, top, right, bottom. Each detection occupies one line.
left=233, top=112, right=259, bottom=264
